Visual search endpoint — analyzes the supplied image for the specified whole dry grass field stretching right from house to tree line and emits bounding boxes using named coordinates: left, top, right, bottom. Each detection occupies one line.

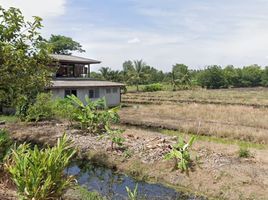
left=120, top=88, right=268, bottom=145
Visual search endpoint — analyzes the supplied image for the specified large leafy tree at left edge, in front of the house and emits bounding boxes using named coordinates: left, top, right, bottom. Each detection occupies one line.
left=0, top=7, right=52, bottom=114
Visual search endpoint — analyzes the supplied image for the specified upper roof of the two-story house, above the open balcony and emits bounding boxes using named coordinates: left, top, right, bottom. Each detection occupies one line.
left=50, top=54, right=101, bottom=64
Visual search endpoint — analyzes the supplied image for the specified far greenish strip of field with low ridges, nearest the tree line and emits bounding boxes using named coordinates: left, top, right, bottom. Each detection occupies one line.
left=122, top=88, right=268, bottom=107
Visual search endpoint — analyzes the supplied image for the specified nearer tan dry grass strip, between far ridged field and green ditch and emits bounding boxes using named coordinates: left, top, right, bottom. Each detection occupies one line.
left=120, top=104, right=268, bottom=144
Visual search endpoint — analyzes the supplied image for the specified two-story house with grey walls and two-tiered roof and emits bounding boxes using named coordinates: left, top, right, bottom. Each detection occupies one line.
left=48, top=54, right=124, bottom=106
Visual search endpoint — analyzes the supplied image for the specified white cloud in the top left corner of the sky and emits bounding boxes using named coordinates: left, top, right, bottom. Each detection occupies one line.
left=1, top=0, right=66, bottom=19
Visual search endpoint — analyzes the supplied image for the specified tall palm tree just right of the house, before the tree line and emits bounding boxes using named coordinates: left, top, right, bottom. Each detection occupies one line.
left=128, top=60, right=148, bottom=91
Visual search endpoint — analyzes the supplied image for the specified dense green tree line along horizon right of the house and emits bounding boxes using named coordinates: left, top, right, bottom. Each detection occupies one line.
left=91, top=60, right=268, bottom=90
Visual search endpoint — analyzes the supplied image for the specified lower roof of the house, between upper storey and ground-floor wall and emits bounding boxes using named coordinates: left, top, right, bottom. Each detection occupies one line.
left=50, top=79, right=124, bottom=88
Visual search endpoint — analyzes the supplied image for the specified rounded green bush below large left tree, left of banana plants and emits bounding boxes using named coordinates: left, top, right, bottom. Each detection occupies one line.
left=26, top=93, right=54, bottom=122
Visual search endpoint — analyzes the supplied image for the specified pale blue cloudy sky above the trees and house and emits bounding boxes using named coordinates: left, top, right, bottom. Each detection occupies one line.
left=0, top=0, right=268, bottom=71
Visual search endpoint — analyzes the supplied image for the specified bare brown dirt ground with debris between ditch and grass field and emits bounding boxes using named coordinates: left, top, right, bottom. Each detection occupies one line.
left=0, top=122, right=268, bottom=199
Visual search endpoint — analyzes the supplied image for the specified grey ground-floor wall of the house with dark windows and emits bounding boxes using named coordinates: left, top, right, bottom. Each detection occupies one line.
left=51, top=87, right=121, bottom=107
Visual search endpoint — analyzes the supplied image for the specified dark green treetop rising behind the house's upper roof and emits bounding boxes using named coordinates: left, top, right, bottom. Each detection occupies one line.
left=48, top=35, right=85, bottom=55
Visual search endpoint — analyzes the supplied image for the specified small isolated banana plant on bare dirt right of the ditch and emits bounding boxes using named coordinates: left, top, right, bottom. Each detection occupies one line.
left=165, top=136, right=195, bottom=172
